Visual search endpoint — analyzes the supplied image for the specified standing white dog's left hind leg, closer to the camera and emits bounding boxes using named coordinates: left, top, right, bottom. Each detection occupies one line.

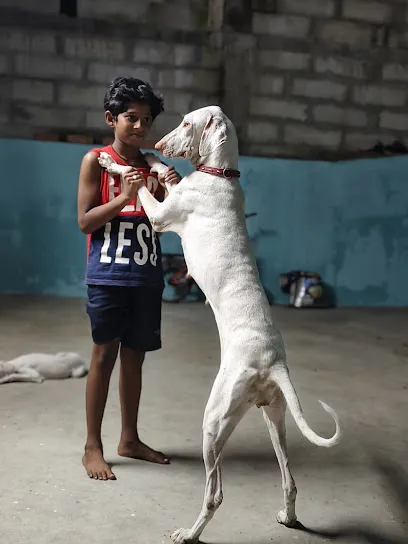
left=171, top=374, right=251, bottom=544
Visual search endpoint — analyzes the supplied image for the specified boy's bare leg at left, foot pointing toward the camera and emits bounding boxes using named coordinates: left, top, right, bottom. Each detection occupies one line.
left=82, top=340, right=119, bottom=480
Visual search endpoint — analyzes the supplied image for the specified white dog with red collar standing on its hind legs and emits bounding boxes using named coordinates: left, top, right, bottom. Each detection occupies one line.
left=100, top=106, right=340, bottom=544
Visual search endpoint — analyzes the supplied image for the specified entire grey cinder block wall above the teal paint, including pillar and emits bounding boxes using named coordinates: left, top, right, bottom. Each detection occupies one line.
left=0, top=0, right=408, bottom=158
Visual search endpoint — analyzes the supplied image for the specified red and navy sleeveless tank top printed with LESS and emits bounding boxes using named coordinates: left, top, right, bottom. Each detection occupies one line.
left=85, top=146, right=164, bottom=288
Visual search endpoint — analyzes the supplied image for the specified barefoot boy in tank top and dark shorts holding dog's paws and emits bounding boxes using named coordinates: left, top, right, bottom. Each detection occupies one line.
left=78, top=77, right=180, bottom=480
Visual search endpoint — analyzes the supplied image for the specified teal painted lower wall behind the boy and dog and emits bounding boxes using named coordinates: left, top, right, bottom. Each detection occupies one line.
left=0, top=136, right=408, bottom=306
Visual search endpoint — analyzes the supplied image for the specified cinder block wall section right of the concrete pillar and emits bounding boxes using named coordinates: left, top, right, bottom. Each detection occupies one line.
left=246, top=0, right=408, bottom=156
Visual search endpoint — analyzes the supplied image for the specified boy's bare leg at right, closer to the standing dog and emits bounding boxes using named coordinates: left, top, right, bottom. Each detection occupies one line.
left=118, top=346, right=169, bottom=464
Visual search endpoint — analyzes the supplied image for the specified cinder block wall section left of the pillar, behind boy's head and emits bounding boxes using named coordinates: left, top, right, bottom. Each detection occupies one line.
left=0, top=0, right=221, bottom=142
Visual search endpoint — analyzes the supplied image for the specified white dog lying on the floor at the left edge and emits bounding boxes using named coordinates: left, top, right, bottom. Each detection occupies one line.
left=0, top=352, right=88, bottom=384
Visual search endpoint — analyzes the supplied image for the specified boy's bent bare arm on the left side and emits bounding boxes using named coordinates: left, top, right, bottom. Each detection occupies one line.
left=78, top=151, right=131, bottom=234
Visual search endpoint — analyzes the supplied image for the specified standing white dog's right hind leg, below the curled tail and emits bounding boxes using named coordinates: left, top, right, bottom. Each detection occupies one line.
left=263, top=391, right=297, bottom=527
